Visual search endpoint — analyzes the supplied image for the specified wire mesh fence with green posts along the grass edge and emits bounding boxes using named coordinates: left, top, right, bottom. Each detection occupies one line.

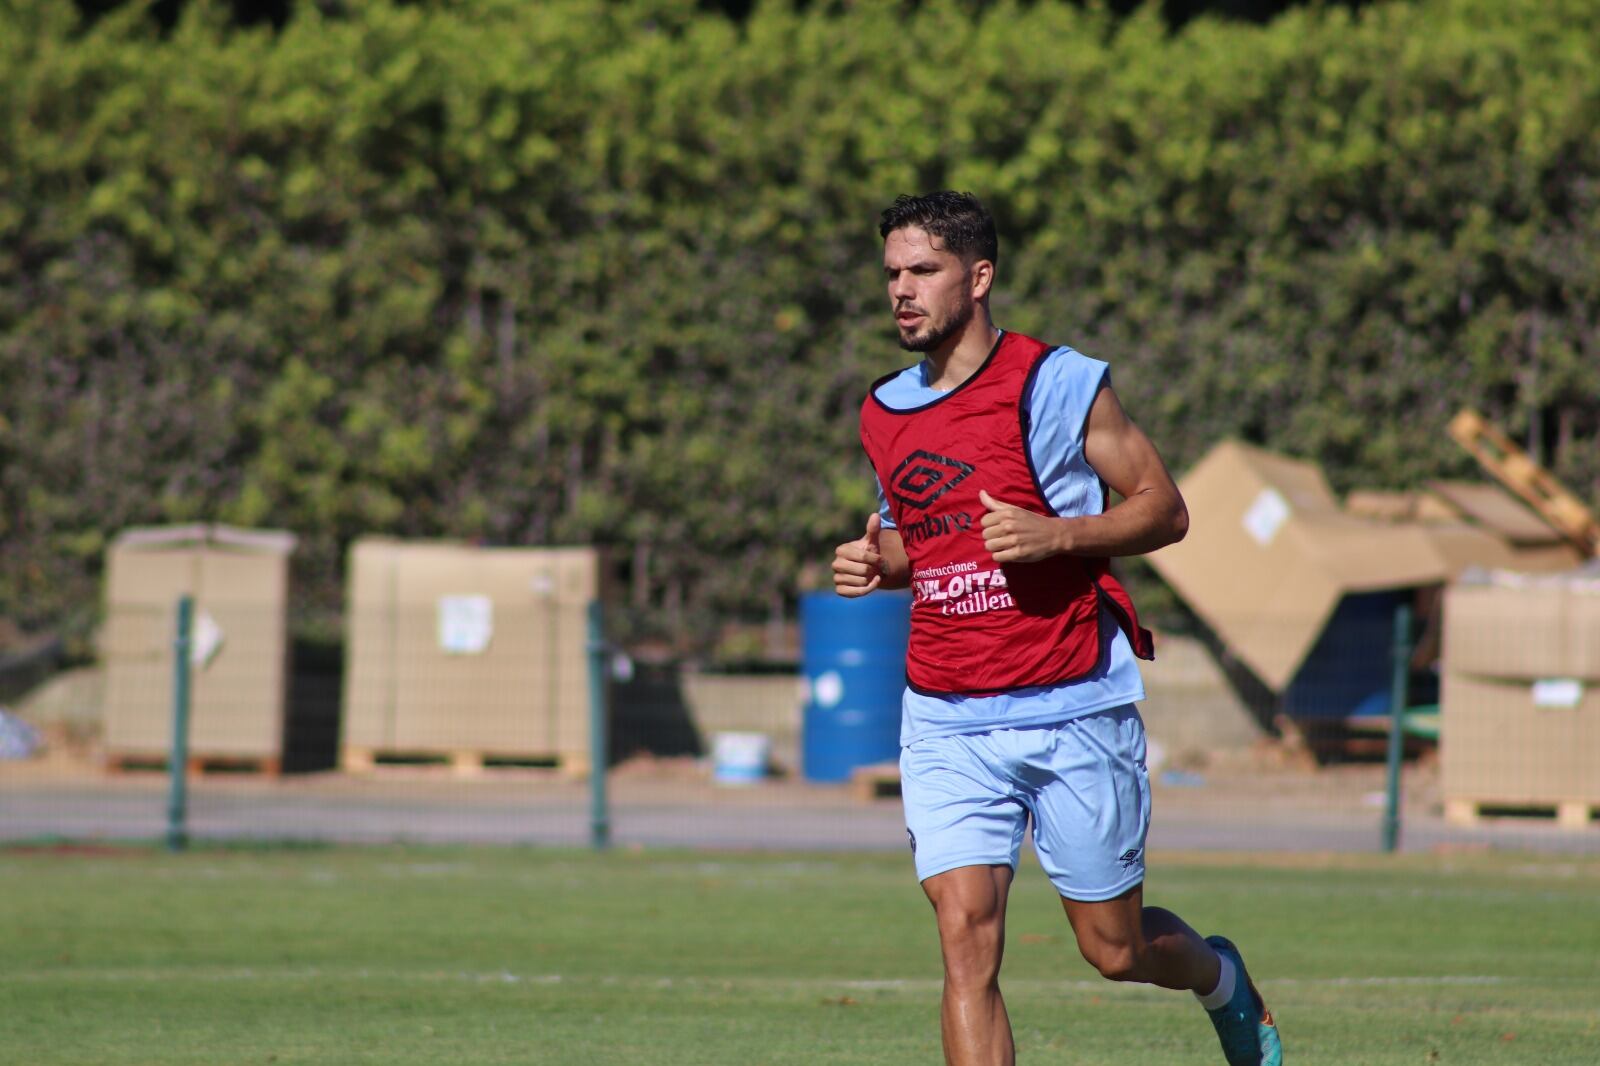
left=0, top=583, right=1600, bottom=853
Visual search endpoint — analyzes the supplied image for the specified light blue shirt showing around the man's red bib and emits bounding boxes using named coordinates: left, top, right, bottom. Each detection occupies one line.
left=877, top=337, right=1144, bottom=746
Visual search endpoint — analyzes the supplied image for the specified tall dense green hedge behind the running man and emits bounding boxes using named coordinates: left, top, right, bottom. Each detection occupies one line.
left=0, top=0, right=1600, bottom=642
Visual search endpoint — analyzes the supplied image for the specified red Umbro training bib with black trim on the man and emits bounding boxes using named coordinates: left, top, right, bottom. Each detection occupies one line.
left=861, top=333, right=1155, bottom=695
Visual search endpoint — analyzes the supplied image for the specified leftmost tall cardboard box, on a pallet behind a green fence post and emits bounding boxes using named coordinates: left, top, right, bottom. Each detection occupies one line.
left=101, top=525, right=296, bottom=762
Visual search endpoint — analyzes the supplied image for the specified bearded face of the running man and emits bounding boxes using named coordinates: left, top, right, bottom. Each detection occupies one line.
left=883, top=226, right=978, bottom=352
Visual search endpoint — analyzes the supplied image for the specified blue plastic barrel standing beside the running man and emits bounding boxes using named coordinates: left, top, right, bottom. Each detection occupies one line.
left=800, top=591, right=910, bottom=781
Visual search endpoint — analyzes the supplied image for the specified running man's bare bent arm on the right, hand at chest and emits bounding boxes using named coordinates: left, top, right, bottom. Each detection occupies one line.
left=981, top=384, right=1189, bottom=563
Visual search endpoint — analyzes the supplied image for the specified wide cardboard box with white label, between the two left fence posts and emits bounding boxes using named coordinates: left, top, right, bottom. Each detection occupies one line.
left=342, top=538, right=602, bottom=767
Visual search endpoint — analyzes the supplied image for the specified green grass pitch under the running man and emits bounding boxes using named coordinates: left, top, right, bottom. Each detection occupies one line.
left=0, top=848, right=1600, bottom=1066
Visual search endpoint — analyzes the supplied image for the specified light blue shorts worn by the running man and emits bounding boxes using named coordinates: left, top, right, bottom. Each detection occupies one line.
left=901, top=704, right=1150, bottom=901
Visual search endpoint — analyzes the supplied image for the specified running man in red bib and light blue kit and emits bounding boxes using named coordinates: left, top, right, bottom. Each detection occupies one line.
left=834, top=192, right=1282, bottom=1066
